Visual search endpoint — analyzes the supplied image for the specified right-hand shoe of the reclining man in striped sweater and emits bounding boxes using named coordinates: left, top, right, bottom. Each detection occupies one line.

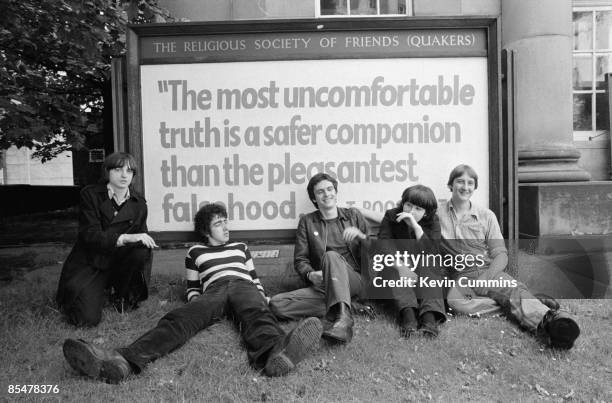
left=264, top=317, right=323, bottom=376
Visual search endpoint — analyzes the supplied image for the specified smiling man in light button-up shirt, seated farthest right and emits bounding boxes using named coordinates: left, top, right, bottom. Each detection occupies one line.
left=438, top=165, right=580, bottom=349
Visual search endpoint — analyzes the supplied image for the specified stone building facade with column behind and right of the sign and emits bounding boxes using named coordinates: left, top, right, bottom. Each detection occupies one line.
left=146, top=0, right=612, bottom=237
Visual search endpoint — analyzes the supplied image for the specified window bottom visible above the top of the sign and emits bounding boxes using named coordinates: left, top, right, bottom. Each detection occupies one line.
left=316, top=0, right=413, bottom=17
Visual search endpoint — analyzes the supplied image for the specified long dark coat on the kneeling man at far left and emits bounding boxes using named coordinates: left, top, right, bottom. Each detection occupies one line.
left=57, top=184, right=148, bottom=306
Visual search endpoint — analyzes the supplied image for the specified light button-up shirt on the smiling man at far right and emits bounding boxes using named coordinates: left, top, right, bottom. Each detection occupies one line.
left=438, top=200, right=508, bottom=268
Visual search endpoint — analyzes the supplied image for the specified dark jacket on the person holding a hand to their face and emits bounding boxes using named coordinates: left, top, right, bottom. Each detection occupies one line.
left=378, top=207, right=441, bottom=253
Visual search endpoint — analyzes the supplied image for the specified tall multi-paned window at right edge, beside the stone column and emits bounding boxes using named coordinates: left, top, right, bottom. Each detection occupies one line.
left=572, top=2, right=612, bottom=140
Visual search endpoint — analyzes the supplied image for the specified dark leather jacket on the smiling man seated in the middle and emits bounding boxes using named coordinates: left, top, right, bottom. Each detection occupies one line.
left=293, top=207, right=368, bottom=281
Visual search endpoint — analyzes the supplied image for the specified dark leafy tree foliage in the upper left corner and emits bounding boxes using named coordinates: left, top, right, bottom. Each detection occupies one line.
left=0, top=0, right=168, bottom=161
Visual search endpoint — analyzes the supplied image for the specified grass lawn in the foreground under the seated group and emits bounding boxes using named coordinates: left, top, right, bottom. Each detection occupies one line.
left=0, top=247, right=612, bottom=402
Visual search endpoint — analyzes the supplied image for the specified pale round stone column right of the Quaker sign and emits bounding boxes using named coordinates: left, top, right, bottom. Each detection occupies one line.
left=501, top=0, right=590, bottom=183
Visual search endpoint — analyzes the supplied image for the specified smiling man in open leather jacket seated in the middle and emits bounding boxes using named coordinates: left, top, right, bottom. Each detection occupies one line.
left=270, top=173, right=368, bottom=343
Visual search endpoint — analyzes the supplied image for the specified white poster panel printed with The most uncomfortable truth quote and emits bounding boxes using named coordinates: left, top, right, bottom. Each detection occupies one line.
left=140, top=57, right=489, bottom=231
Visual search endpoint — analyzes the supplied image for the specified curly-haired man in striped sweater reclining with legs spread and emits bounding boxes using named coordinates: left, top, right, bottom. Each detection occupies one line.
left=64, top=204, right=322, bottom=383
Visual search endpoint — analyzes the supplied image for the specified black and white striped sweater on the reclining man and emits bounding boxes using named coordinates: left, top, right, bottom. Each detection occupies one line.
left=185, top=242, right=266, bottom=301
